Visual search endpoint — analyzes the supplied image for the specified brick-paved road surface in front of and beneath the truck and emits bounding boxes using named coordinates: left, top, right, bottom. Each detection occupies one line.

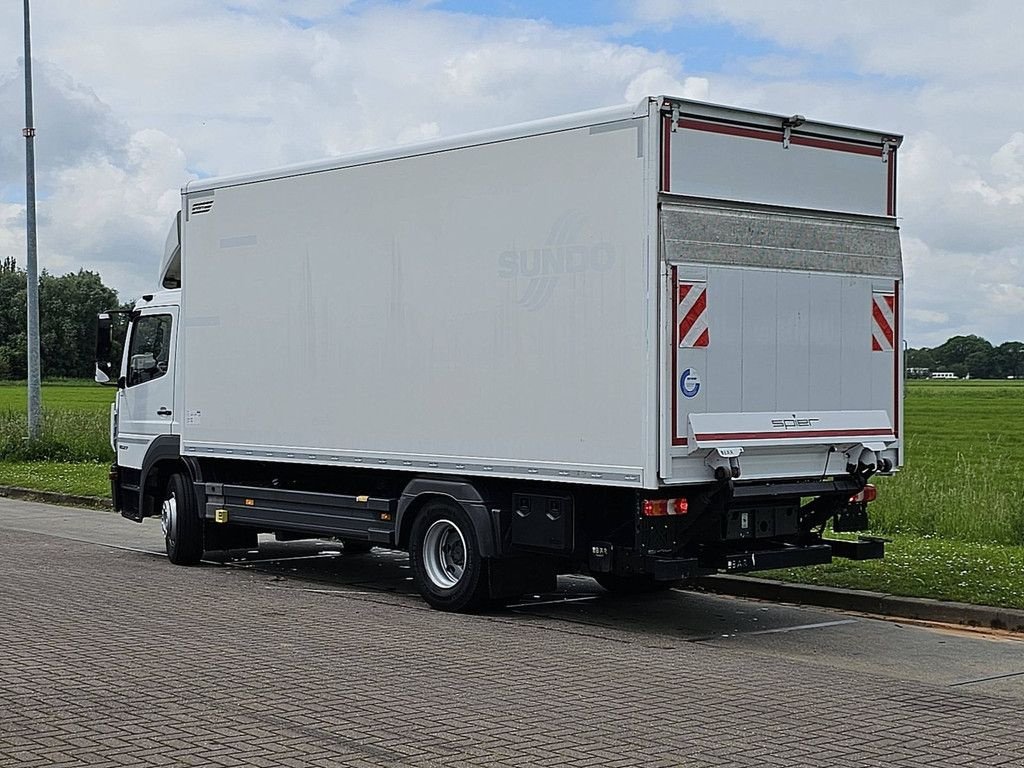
left=0, top=500, right=1024, bottom=767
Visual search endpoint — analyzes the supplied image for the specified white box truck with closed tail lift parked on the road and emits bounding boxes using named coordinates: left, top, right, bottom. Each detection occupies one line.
left=97, top=96, right=903, bottom=610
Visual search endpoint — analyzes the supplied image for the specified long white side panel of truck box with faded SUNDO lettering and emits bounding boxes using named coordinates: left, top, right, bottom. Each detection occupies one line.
left=182, top=119, right=652, bottom=485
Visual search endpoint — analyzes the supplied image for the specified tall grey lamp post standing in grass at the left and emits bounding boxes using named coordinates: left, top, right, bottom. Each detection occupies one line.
left=22, top=0, right=42, bottom=440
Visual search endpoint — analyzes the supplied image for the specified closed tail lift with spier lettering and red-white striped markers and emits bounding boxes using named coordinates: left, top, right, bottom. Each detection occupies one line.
left=660, top=200, right=901, bottom=482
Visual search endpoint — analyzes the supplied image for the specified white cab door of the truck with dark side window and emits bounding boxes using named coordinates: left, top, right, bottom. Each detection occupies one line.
left=117, top=306, right=178, bottom=469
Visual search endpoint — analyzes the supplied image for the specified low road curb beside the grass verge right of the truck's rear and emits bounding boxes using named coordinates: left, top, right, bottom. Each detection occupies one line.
left=695, top=575, right=1024, bottom=632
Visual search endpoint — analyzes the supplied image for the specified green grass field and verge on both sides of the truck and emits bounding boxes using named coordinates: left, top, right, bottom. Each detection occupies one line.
left=0, top=381, right=1024, bottom=608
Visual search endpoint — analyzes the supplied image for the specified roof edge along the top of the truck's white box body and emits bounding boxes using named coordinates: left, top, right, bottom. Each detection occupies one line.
left=181, top=96, right=903, bottom=195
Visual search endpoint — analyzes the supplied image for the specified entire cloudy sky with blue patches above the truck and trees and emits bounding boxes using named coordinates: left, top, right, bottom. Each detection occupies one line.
left=0, top=0, right=1024, bottom=347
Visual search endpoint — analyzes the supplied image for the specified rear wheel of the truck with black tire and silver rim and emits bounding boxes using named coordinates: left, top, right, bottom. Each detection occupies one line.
left=409, top=502, right=489, bottom=613
